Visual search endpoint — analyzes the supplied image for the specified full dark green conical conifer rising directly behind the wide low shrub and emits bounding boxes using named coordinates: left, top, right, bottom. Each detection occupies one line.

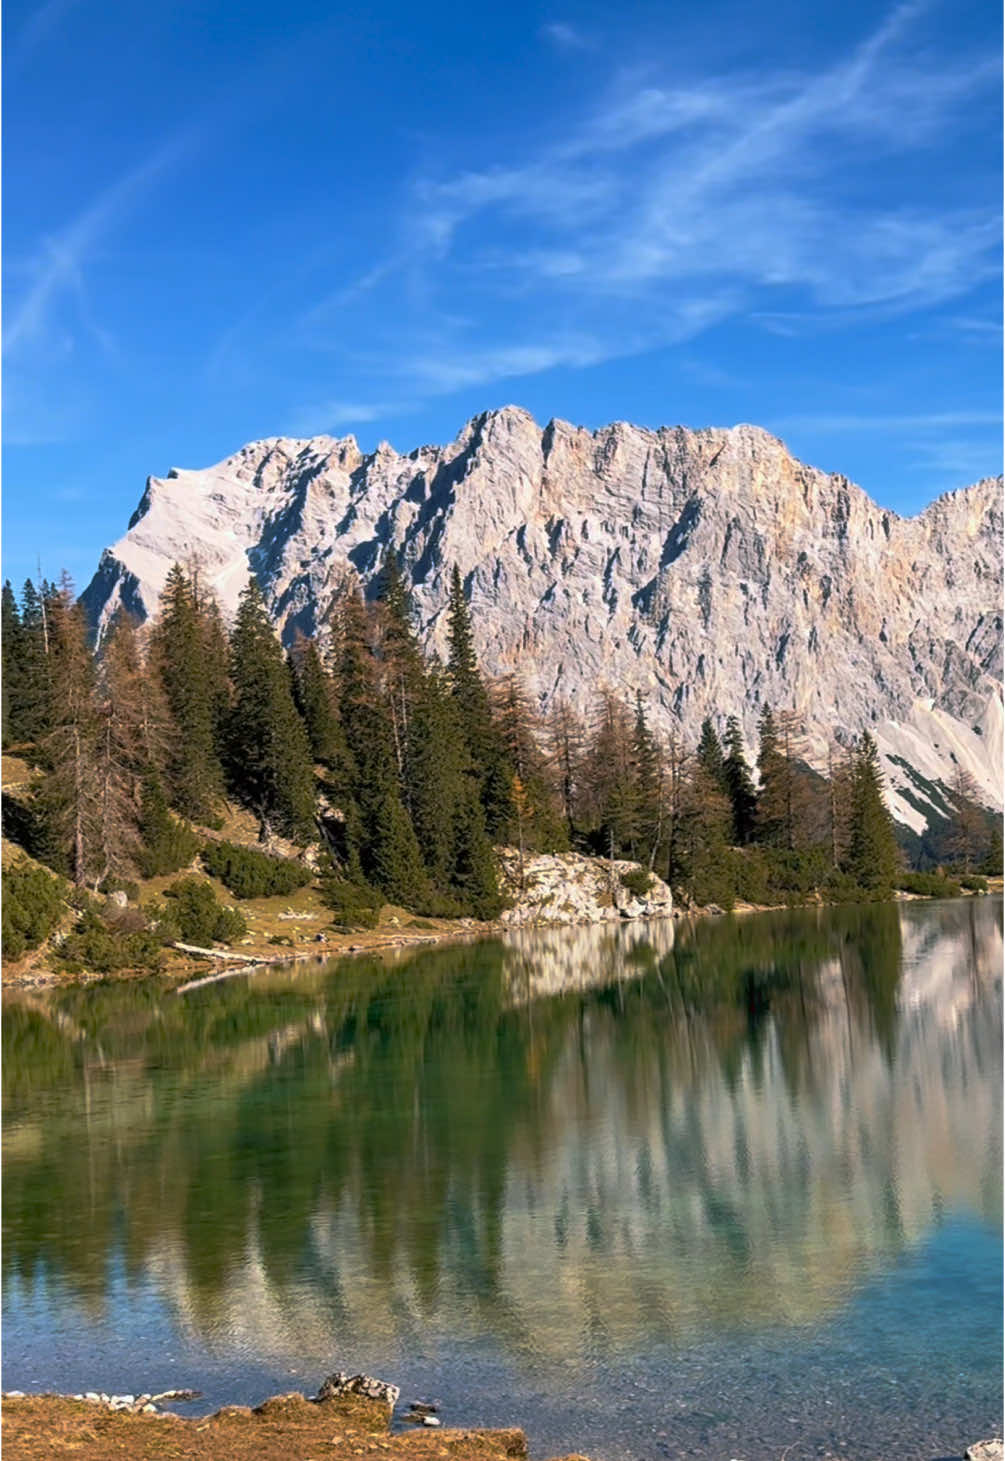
left=228, top=579, right=314, bottom=843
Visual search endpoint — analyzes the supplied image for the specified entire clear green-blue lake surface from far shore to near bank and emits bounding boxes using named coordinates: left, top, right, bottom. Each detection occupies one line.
left=3, top=899, right=1002, bottom=1461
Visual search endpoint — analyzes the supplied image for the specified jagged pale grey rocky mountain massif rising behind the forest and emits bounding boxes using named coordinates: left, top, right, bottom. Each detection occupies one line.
left=83, top=406, right=1002, bottom=830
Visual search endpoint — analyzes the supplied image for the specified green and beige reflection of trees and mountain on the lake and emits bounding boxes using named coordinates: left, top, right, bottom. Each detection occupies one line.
left=3, top=900, right=1002, bottom=1363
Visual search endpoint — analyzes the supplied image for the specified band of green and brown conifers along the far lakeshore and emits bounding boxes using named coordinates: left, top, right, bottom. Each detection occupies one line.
left=1, top=554, right=1002, bottom=967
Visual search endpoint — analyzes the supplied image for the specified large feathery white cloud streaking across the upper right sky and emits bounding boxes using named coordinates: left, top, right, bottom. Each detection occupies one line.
left=289, top=0, right=1001, bottom=417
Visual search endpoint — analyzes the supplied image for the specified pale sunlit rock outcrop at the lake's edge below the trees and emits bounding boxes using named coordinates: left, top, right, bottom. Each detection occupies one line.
left=500, top=847, right=673, bottom=925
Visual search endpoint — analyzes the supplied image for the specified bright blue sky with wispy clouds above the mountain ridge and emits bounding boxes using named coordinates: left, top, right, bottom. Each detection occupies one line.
left=3, top=0, right=1002, bottom=586
